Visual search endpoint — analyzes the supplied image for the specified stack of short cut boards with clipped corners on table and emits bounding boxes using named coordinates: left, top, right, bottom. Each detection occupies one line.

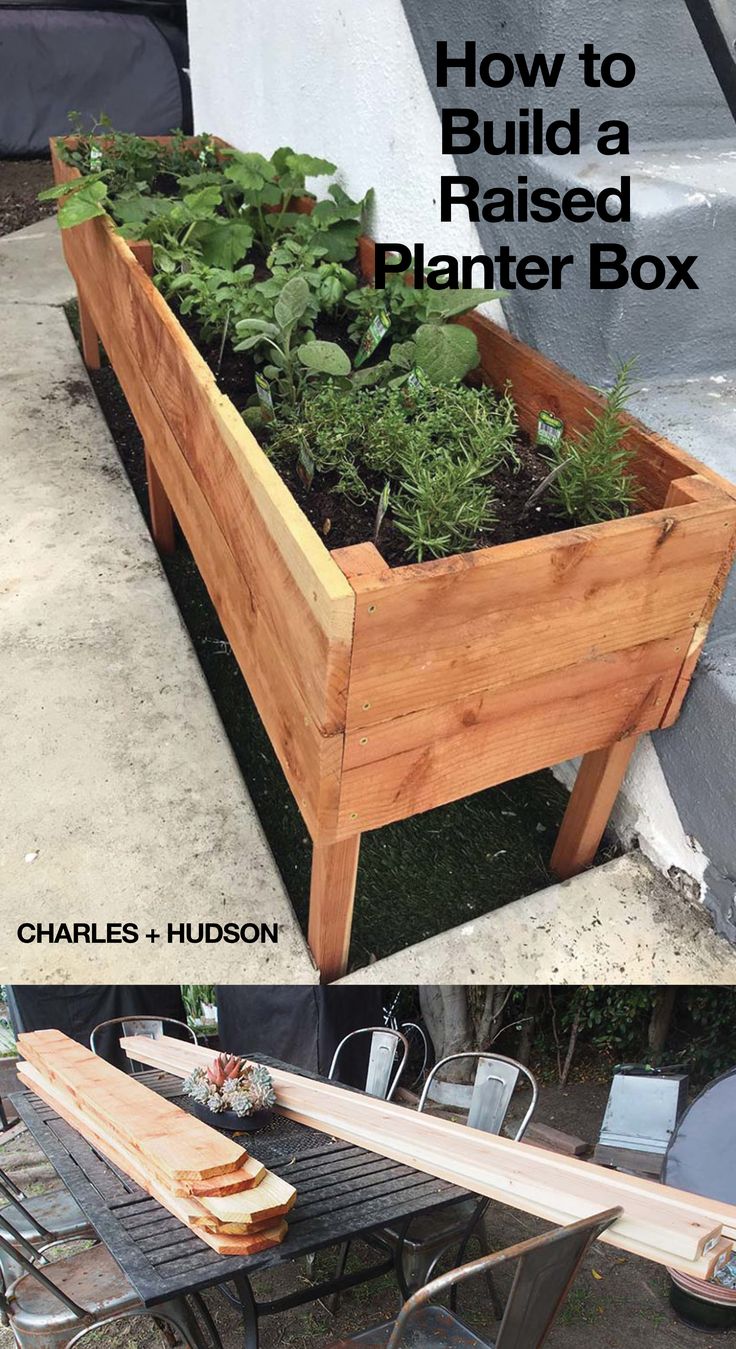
left=18, top=1031, right=297, bottom=1256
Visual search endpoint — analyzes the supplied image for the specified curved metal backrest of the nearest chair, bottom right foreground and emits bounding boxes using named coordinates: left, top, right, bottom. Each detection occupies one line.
left=387, top=1209, right=623, bottom=1349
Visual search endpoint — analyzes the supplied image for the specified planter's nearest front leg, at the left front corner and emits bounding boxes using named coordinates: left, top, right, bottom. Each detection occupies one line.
left=307, top=834, right=360, bottom=983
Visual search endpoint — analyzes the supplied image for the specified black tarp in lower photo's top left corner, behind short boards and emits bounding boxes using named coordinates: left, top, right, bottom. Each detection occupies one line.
left=7, top=983, right=186, bottom=1067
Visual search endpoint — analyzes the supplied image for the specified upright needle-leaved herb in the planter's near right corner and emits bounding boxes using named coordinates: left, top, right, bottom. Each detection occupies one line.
left=547, top=360, right=638, bottom=525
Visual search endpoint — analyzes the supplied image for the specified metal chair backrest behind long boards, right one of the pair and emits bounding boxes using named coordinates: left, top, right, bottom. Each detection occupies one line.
left=417, top=1051, right=539, bottom=1141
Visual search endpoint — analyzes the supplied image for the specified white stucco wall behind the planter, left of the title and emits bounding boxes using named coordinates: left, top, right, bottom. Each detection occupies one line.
left=187, top=0, right=500, bottom=318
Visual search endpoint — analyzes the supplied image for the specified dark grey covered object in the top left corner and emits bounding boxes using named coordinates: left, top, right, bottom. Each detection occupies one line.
left=0, top=0, right=190, bottom=158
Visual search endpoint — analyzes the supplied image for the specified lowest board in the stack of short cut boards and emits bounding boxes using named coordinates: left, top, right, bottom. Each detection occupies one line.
left=19, top=1063, right=287, bottom=1255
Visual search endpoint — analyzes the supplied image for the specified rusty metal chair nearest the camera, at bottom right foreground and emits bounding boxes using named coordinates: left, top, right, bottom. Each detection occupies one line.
left=330, top=1209, right=623, bottom=1349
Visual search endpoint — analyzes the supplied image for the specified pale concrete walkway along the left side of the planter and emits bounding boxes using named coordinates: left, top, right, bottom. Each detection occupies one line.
left=0, top=221, right=317, bottom=983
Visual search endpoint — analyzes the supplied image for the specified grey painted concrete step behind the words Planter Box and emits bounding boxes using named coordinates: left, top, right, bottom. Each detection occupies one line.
left=493, top=136, right=736, bottom=384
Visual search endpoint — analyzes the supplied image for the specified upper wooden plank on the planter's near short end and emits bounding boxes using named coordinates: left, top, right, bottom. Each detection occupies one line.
left=337, top=495, right=736, bottom=733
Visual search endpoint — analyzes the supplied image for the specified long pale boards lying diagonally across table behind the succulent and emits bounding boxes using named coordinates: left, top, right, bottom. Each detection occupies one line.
left=120, top=1036, right=736, bottom=1279
